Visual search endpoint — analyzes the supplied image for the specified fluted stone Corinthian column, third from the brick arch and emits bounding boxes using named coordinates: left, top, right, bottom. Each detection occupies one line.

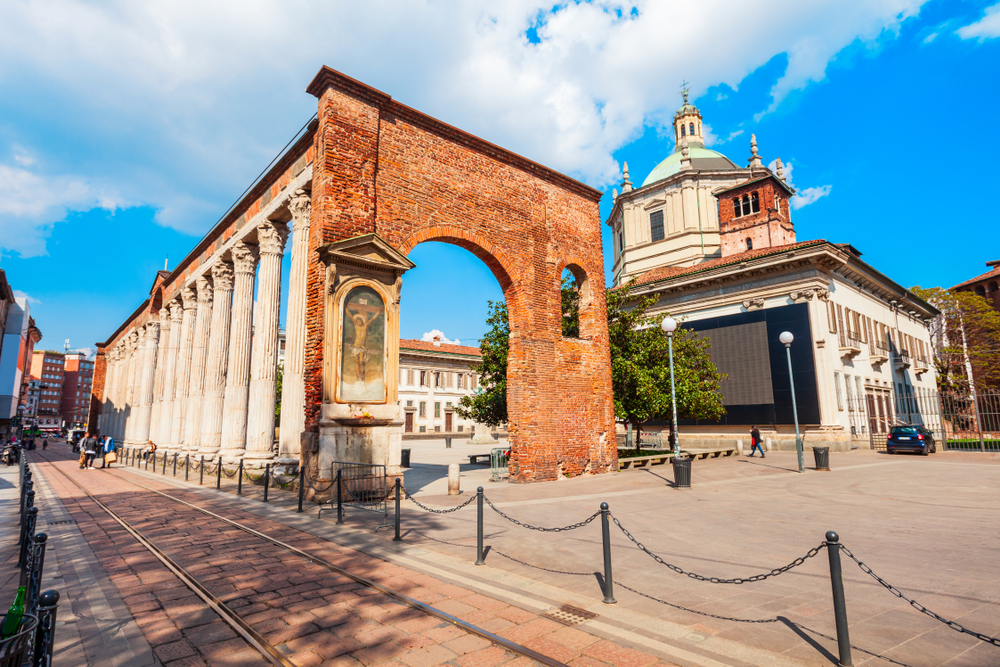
left=220, top=241, right=257, bottom=459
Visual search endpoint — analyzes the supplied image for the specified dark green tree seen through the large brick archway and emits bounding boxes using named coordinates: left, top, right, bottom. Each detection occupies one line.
left=455, top=301, right=510, bottom=426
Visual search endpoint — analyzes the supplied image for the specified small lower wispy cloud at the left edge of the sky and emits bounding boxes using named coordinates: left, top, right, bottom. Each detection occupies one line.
left=0, top=159, right=120, bottom=257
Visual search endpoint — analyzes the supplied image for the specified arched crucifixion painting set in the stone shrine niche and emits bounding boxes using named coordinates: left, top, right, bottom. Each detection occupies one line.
left=340, top=286, right=385, bottom=402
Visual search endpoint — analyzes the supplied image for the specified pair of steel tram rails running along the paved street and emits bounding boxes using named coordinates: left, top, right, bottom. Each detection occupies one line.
left=35, top=454, right=567, bottom=667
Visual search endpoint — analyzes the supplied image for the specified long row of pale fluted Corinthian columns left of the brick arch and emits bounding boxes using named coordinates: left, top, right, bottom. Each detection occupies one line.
left=99, top=190, right=310, bottom=465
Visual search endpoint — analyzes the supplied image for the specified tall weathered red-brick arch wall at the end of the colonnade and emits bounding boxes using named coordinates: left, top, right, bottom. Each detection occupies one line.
left=306, top=68, right=617, bottom=482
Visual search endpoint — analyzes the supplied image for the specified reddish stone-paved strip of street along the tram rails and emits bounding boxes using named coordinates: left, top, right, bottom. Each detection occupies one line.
left=33, top=446, right=673, bottom=667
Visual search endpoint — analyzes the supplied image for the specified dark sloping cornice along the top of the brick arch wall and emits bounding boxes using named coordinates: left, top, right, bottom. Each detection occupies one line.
left=306, top=65, right=604, bottom=202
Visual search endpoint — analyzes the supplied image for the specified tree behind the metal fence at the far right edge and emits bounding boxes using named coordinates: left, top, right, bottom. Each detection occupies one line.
left=911, top=287, right=1000, bottom=391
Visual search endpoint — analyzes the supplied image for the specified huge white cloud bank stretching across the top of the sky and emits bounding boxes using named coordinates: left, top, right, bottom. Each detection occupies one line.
left=0, top=0, right=924, bottom=253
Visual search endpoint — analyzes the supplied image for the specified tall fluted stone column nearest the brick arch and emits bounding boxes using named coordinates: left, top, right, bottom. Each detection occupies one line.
left=278, top=190, right=312, bottom=466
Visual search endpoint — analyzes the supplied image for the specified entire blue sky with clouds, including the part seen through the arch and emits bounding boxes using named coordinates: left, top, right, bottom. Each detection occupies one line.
left=0, top=0, right=1000, bottom=349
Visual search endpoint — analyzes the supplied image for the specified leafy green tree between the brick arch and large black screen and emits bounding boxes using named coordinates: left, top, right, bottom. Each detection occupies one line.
left=607, top=283, right=725, bottom=446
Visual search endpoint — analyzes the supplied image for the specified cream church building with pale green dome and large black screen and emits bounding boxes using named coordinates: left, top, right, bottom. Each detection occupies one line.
left=607, top=96, right=938, bottom=449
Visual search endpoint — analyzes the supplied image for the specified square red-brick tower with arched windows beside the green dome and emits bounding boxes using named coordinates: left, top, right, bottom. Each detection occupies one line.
left=719, top=178, right=795, bottom=257
